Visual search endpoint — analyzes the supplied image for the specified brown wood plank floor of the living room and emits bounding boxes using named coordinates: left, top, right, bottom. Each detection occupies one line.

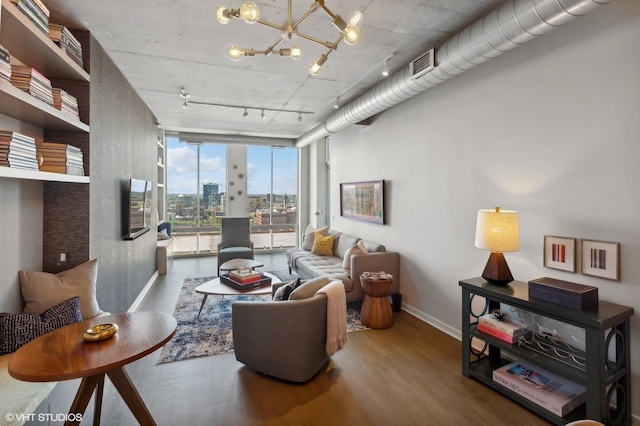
left=90, top=254, right=548, bottom=426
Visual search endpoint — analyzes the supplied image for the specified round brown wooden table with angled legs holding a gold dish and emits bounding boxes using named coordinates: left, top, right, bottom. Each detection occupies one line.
left=8, top=312, right=177, bottom=425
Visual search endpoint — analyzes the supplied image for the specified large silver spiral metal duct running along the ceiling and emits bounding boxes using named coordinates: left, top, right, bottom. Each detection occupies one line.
left=296, top=0, right=612, bottom=148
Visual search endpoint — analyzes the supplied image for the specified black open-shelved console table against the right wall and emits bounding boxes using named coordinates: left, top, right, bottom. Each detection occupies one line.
left=459, top=278, right=633, bottom=425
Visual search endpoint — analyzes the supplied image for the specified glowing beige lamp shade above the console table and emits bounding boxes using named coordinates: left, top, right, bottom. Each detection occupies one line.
left=476, top=207, right=520, bottom=253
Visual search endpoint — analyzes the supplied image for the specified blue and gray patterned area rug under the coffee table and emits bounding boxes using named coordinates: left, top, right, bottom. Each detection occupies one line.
left=158, top=271, right=368, bottom=364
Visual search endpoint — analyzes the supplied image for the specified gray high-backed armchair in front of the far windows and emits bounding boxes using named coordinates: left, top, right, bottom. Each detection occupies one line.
left=218, top=217, right=254, bottom=276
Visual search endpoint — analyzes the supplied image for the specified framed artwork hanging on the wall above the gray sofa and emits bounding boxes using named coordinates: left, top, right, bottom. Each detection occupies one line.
left=340, top=180, right=385, bottom=225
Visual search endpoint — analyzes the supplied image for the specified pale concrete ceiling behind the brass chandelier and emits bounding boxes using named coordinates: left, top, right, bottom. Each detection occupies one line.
left=46, top=0, right=506, bottom=138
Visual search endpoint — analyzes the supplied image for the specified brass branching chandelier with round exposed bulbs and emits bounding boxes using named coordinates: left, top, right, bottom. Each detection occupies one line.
left=216, top=0, right=362, bottom=75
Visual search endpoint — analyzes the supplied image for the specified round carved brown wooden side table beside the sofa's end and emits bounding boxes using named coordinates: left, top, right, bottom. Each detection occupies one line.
left=360, top=275, right=393, bottom=328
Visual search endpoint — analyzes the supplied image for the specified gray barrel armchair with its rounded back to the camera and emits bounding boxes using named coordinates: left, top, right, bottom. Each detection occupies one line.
left=231, top=294, right=329, bottom=383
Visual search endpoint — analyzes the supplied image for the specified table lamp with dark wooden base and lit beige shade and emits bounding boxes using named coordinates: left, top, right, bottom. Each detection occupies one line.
left=476, top=207, right=520, bottom=286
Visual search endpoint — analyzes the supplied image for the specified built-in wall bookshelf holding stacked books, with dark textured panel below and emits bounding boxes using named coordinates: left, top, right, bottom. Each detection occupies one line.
left=0, top=0, right=91, bottom=273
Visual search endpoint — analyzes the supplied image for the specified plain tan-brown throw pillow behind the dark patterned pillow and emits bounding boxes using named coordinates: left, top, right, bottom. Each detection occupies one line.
left=18, top=259, right=102, bottom=319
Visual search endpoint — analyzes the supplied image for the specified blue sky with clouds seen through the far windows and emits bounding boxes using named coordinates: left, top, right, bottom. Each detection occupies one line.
left=167, top=137, right=298, bottom=194
